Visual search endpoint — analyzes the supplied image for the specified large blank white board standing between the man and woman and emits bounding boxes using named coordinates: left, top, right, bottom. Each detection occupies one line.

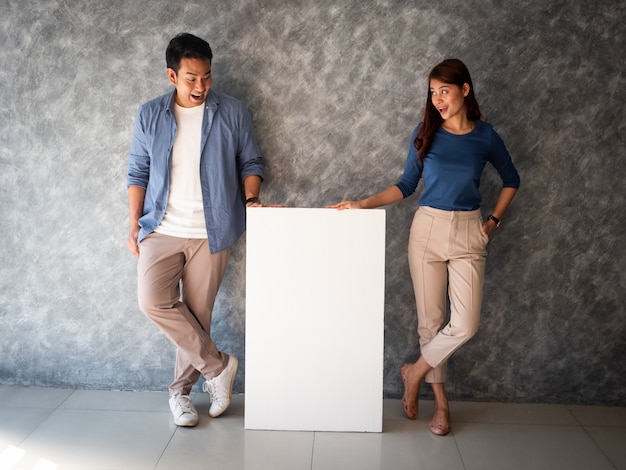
left=245, top=208, right=385, bottom=432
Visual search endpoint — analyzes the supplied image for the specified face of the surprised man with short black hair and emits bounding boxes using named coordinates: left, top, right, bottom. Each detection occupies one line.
left=167, top=57, right=212, bottom=108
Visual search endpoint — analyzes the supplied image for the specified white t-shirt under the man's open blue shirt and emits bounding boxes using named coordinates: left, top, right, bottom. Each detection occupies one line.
left=155, top=104, right=207, bottom=238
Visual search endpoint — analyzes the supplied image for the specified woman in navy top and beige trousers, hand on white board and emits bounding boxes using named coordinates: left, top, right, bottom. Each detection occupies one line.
left=328, top=59, right=520, bottom=436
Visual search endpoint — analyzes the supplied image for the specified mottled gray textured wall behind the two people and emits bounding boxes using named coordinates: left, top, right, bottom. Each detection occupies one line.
left=0, top=0, right=626, bottom=404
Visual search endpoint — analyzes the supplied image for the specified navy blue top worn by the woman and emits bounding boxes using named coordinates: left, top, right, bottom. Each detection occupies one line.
left=396, top=120, right=520, bottom=211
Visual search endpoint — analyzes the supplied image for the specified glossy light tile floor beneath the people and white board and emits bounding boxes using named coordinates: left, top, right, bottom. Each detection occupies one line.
left=0, top=385, right=626, bottom=470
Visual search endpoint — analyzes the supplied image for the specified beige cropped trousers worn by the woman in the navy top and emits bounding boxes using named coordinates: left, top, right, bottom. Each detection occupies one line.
left=409, top=206, right=488, bottom=383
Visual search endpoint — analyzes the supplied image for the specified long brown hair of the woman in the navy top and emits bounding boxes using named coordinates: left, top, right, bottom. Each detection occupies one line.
left=413, top=59, right=482, bottom=162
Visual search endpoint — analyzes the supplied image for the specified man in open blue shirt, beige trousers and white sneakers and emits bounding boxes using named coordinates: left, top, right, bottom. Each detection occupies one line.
left=127, top=33, right=263, bottom=426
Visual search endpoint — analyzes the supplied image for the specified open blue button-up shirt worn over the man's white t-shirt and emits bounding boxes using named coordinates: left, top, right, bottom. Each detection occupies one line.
left=127, top=90, right=264, bottom=253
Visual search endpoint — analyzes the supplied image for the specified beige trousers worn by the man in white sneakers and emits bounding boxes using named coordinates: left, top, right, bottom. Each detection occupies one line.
left=137, top=233, right=230, bottom=394
